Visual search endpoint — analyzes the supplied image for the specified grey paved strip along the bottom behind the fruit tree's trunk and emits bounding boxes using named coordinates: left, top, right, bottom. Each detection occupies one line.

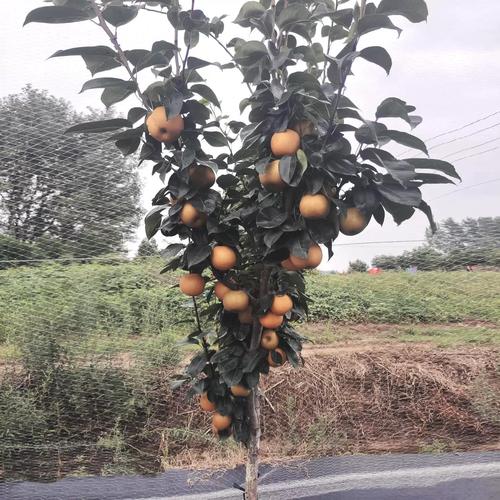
left=0, top=452, right=500, bottom=500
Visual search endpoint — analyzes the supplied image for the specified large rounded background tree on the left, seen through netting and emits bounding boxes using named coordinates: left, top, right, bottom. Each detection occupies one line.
left=0, top=86, right=141, bottom=258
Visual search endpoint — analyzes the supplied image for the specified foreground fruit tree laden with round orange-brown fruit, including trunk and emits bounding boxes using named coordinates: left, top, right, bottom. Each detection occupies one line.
left=26, top=0, right=459, bottom=500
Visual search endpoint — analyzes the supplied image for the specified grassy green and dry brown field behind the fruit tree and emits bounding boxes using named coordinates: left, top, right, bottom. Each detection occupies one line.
left=0, top=259, right=500, bottom=479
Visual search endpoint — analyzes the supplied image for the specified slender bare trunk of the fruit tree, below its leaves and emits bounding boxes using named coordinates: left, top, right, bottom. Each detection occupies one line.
left=245, top=387, right=260, bottom=500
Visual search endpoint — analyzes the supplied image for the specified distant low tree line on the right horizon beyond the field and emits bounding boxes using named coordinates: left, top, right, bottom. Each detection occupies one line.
left=372, top=217, right=500, bottom=271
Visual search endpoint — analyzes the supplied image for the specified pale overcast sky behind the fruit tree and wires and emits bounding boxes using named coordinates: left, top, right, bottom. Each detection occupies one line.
left=0, top=0, right=500, bottom=270
